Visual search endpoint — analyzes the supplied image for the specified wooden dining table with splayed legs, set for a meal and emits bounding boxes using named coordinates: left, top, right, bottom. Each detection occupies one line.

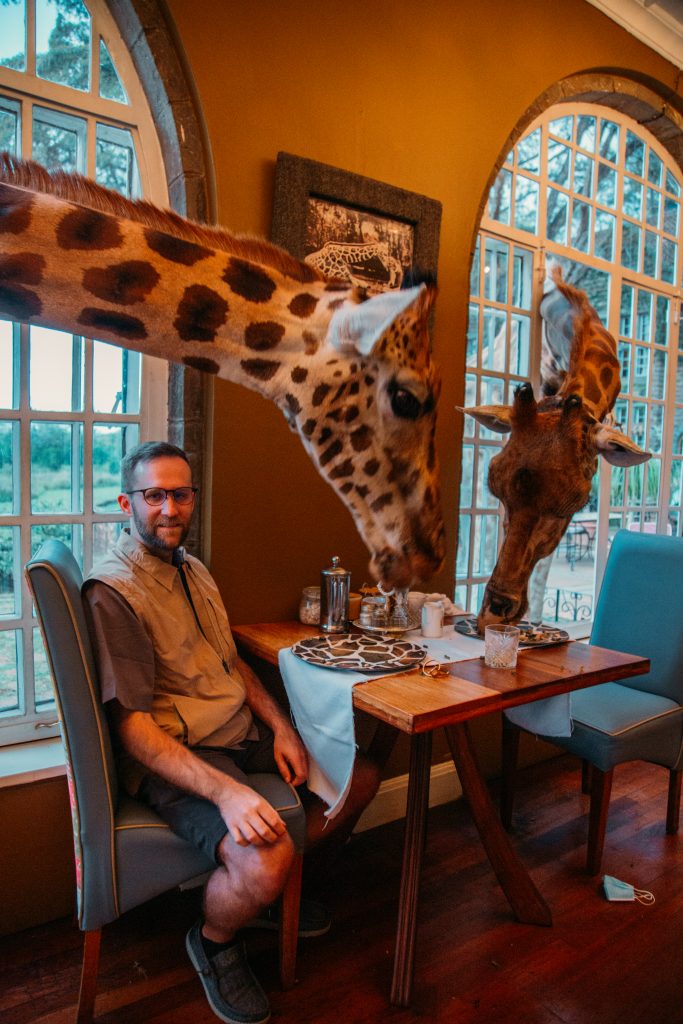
left=232, top=622, right=650, bottom=1007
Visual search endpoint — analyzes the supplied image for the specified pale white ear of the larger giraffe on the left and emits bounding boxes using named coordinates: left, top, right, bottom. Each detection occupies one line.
left=328, top=285, right=426, bottom=355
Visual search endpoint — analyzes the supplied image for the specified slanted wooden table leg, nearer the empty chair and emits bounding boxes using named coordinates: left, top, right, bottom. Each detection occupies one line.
left=445, top=722, right=553, bottom=926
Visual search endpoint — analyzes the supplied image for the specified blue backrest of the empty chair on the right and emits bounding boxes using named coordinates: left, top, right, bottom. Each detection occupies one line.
left=591, top=529, right=683, bottom=705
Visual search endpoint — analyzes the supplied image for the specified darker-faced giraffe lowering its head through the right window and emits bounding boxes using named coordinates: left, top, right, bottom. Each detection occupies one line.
left=464, top=267, right=650, bottom=633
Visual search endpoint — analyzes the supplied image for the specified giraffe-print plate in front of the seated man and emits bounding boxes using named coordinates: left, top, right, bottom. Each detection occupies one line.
left=292, top=633, right=426, bottom=672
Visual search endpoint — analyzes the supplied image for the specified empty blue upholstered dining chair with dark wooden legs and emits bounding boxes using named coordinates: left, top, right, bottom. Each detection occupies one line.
left=501, top=529, right=683, bottom=874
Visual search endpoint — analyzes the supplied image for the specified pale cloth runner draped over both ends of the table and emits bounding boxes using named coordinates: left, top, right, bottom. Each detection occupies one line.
left=280, top=626, right=571, bottom=818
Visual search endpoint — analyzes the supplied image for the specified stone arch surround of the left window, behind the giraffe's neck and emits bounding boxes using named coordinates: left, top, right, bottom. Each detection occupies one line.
left=108, top=0, right=215, bottom=557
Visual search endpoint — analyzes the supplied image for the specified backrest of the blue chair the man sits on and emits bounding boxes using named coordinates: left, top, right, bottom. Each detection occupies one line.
left=26, top=541, right=118, bottom=927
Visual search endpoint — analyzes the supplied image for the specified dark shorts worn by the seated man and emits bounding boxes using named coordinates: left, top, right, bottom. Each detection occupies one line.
left=137, top=722, right=280, bottom=864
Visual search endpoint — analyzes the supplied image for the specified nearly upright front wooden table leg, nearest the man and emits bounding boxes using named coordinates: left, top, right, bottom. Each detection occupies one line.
left=391, top=732, right=432, bottom=1007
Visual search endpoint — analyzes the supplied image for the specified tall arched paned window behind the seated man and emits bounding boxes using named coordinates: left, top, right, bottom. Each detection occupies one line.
left=0, top=0, right=168, bottom=742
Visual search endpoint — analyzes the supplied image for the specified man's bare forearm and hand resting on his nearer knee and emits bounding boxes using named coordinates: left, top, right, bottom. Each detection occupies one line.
left=110, top=700, right=287, bottom=846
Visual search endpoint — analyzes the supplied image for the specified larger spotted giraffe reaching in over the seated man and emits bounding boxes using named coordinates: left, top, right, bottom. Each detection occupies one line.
left=0, top=154, right=444, bottom=587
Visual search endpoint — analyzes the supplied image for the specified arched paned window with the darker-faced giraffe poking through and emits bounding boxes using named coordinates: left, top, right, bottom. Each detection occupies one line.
left=456, top=102, right=683, bottom=623
